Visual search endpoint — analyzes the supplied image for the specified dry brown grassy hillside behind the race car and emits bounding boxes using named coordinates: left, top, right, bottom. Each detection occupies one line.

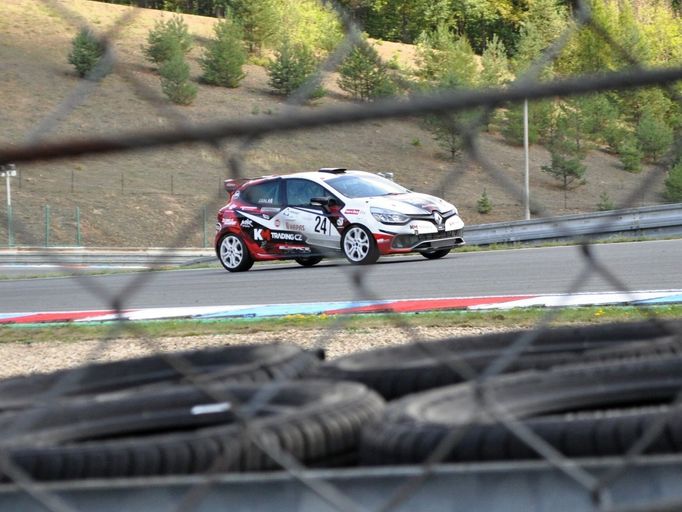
left=0, top=0, right=663, bottom=247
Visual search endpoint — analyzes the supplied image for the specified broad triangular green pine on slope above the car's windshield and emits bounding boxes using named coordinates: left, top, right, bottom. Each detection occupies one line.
left=338, top=41, right=396, bottom=101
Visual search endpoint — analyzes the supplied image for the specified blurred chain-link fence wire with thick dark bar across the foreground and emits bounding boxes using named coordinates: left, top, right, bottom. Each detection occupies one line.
left=0, top=0, right=682, bottom=512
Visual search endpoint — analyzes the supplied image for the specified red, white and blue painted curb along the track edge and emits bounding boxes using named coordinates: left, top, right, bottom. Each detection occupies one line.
left=0, top=290, right=682, bottom=324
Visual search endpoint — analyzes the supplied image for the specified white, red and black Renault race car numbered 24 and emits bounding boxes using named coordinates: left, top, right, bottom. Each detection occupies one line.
left=215, top=168, right=465, bottom=272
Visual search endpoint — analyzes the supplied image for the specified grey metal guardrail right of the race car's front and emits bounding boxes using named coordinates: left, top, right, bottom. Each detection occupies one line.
left=464, top=204, right=682, bottom=245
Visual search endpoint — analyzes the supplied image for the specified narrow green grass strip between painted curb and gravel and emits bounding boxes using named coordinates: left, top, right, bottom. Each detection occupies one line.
left=0, top=305, right=682, bottom=343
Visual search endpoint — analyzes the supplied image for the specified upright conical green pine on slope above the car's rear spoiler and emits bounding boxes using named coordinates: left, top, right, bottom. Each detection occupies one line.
left=199, top=18, right=246, bottom=87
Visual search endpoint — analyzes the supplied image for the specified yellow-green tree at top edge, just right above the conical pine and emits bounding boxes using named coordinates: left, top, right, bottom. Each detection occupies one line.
left=230, top=0, right=280, bottom=54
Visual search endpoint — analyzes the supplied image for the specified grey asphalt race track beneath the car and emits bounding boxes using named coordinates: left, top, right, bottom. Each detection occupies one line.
left=0, top=240, right=682, bottom=313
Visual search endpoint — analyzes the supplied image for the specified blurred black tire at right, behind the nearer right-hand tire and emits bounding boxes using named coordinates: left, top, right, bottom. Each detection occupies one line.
left=313, top=321, right=682, bottom=400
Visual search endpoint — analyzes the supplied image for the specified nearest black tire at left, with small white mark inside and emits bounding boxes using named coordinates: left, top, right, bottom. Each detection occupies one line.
left=8, top=381, right=383, bottom=480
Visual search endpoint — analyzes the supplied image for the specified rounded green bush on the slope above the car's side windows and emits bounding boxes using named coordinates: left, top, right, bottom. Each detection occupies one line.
left=267, top=40, right=324, bottom=98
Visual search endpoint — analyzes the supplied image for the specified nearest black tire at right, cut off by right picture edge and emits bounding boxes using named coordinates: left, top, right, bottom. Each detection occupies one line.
left=361, top=357, right=682, bottom=464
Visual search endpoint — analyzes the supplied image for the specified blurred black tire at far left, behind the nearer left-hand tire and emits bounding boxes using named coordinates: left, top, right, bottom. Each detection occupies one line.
left=0, top=343, right=323, bottom=410
